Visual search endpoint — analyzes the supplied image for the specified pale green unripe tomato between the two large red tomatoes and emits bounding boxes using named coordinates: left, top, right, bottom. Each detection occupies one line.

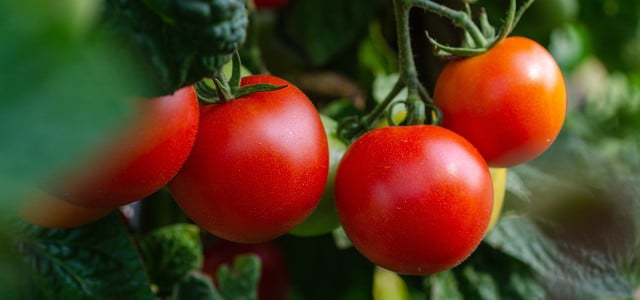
left=290, top=114, right=347, bottom=236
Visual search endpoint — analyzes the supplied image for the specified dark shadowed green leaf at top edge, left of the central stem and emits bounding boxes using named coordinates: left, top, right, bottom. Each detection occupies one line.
left=283, top=0, right=382, bottom=66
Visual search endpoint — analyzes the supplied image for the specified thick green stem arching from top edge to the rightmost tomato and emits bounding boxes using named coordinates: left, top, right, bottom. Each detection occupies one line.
left=402, top=0, right=488, bottom=48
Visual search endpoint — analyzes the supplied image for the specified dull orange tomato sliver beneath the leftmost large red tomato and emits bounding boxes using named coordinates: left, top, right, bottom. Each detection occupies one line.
left=18, top=190, right=113, bottom=228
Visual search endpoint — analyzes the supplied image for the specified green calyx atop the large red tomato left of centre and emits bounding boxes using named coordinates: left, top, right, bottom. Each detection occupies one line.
left=194, top=53, right=287, bottom=104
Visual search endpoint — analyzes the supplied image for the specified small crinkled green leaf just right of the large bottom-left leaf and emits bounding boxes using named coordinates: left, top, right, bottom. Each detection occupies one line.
left=140, top=224, right=203, bottom=291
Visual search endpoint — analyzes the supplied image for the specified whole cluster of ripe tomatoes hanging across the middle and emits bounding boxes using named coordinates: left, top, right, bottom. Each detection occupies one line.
left=22, top=37, right=566, bottom=275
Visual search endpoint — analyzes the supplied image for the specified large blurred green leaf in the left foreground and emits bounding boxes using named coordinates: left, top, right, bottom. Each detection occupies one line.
left=0, top=0, right=143, bottom=211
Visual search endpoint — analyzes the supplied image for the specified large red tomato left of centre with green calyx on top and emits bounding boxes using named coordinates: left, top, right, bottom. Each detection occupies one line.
left=169, top=75, right=329, bottom=243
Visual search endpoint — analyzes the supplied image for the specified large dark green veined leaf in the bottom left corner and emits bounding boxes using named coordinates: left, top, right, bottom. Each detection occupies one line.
left=13, top=213, right=154, bottom=299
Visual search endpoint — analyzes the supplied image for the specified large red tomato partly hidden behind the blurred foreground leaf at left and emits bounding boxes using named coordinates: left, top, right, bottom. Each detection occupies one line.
left=52, top=87, right=199, bottom=208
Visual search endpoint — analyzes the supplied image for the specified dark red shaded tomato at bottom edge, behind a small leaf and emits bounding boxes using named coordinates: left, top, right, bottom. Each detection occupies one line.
left=202, top=240, right=289, bottom=300
